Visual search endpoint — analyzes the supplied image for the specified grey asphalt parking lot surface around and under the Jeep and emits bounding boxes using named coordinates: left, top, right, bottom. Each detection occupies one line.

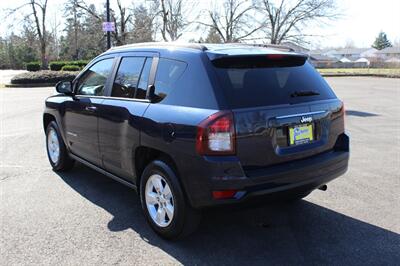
left=0, top=77, right=400, bottom=265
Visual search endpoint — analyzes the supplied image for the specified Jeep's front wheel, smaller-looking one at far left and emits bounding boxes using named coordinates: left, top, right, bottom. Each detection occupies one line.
left=46, top=121, right=74, bottom=171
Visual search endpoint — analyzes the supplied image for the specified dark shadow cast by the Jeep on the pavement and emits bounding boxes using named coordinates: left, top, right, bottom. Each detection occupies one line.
left=58, top=164, right=400, bottom=265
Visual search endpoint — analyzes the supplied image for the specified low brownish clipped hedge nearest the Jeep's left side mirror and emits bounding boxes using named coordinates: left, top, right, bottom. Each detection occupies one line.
left=11, top=70, right=79, bottom=84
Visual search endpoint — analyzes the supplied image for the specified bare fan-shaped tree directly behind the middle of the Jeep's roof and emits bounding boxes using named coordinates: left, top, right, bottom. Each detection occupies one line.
left=199, top=0, right=263, bottom=43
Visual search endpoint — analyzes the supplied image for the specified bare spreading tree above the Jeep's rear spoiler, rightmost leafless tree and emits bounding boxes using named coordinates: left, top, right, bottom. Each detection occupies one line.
left=255, top=0, right=338, bottom=44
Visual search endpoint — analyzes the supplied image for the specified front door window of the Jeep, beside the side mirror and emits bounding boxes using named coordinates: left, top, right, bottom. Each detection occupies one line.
left=77, top=58, right=114, bottom=96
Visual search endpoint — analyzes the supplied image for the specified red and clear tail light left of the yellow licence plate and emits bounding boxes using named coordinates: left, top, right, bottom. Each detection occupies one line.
left=196, top=111, right=235, bottom=155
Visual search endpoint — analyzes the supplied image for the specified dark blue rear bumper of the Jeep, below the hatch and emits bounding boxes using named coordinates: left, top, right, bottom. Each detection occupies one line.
left=177, top=133, right=349, bottom=208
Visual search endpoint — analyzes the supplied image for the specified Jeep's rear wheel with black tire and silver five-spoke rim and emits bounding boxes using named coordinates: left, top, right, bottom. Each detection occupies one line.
left=140, top=160, right=201, bottom=240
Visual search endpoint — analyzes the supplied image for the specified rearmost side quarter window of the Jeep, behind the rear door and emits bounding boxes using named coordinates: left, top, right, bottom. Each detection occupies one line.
left=154, top=58, right=186, bottom=101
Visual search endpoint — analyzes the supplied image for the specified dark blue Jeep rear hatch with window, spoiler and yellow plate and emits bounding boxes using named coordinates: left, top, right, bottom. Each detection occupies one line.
left=213, top=54, right=344, bottom=174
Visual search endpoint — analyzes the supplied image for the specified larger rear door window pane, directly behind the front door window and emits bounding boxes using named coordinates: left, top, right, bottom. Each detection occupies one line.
left=111, top=57, right=146, bottom=98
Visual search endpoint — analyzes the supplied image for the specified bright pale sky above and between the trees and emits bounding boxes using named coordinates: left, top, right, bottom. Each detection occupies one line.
left=0, top=0, right=400, bottom=48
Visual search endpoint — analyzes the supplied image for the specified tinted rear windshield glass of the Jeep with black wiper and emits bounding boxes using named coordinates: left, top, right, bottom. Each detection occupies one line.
left=214, top=60, right=336, bottom=108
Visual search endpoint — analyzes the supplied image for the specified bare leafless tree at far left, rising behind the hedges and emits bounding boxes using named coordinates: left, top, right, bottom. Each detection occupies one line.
left=9, top=0, right=48, bottom=69
